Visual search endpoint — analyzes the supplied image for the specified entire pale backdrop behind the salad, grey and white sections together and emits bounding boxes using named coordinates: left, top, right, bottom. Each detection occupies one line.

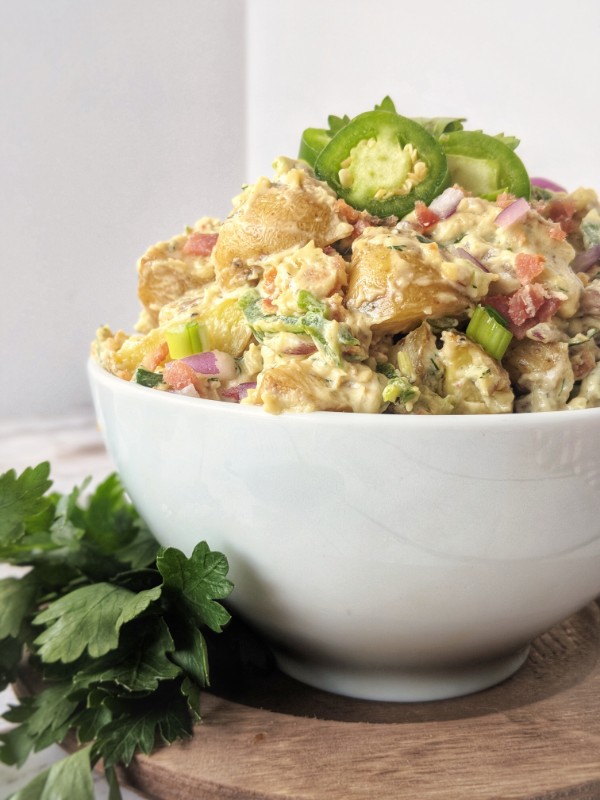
left=0, top=0, right=600, bottom=417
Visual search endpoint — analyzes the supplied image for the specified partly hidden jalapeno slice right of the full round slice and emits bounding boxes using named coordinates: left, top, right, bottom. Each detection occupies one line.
left=439, top=131, right=531, bottom=200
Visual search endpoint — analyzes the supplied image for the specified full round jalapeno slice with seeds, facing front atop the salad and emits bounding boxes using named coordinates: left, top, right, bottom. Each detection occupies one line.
left=314, top=108, right=448, bottom=217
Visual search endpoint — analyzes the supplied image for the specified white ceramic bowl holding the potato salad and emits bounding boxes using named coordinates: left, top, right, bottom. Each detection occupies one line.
left=89, top=363, right=600, bottom=701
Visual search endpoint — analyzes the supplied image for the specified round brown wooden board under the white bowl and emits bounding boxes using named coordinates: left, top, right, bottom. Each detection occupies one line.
left=17, top=603, right=600, bottom=800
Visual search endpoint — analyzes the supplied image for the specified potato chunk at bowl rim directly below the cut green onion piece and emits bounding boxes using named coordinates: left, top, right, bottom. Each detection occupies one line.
left=439, top=331, right=514, bottom=414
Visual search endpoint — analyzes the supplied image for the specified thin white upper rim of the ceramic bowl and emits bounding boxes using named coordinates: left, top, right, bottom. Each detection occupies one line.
left=87, top=356, right=600, bottom=432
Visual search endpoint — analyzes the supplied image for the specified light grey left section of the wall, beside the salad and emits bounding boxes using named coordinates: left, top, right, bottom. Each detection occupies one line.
left=0, top=0, right=245, bottom=417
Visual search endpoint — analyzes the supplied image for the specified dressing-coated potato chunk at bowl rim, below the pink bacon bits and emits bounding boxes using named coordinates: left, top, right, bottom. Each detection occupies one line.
left=504, top=339, right=575, bottom=411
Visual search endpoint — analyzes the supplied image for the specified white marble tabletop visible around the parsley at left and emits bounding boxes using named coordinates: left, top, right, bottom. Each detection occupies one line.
left=0, top=408, right=140, bottom=800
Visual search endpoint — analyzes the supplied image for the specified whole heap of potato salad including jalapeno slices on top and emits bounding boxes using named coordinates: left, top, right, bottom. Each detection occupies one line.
left=92, top=97, right=600, bottom=414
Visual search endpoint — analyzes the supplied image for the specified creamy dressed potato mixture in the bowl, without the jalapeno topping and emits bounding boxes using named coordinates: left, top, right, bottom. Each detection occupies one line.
left=93, top=158, right=600, bottom=414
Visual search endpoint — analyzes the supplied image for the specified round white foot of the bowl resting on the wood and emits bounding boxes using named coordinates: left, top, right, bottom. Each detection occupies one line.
left=275, top=645, right=529, bottom=703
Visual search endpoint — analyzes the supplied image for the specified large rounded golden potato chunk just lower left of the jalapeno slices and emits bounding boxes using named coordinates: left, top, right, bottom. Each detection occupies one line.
left=213, top=174, right=352, bottom=291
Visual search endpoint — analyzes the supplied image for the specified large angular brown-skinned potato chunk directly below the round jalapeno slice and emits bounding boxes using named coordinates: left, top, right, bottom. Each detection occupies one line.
left=346, top=229, right=470, bottom=333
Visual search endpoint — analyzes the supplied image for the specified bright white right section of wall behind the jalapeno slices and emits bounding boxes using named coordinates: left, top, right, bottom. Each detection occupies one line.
left=248, top=0, right=600, bottom=189
